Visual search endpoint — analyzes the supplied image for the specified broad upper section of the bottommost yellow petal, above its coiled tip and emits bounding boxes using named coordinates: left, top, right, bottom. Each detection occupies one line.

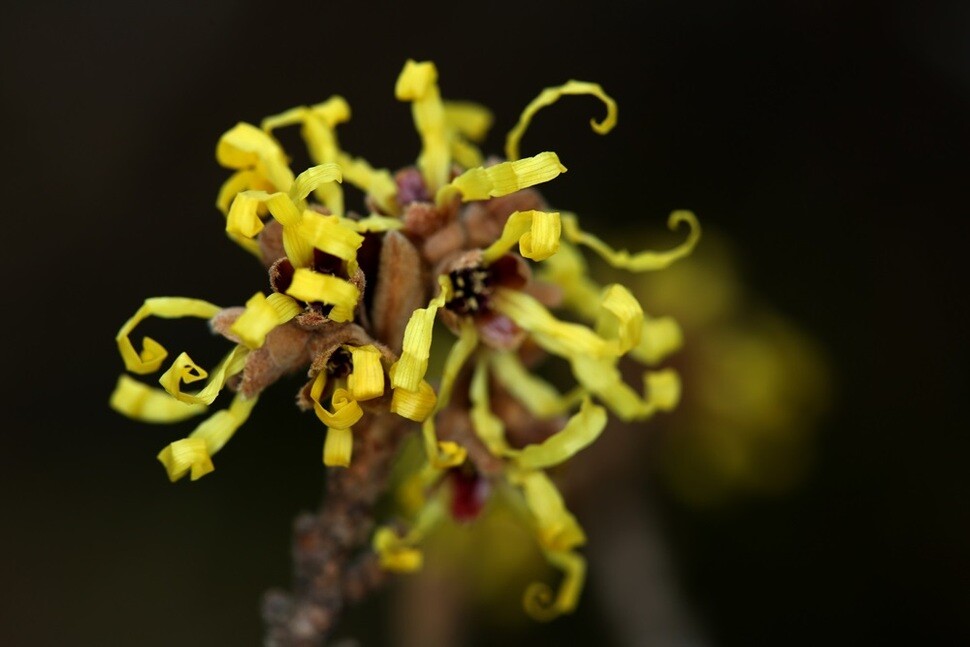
left=510, top=471, right=586, bottom=552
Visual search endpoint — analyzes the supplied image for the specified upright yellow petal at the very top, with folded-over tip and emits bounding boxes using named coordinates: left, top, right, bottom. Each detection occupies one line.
left=394, top=59, right=451, bottom=193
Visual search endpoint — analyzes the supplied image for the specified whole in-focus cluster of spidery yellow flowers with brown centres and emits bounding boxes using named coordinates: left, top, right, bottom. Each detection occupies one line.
left=111, top=61, right=700, bottom=618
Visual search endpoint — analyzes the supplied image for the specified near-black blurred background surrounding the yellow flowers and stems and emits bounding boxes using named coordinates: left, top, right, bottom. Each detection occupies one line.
left=0, top=0, right=970, bottom=647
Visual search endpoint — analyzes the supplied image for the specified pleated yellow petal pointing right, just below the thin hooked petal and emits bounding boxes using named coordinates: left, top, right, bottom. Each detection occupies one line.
left=437, top=151, right=566, bottom=204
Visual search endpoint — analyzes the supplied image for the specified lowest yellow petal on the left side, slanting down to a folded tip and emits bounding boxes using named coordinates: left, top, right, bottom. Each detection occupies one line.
left=158, top=394, right=258, bottom=482
